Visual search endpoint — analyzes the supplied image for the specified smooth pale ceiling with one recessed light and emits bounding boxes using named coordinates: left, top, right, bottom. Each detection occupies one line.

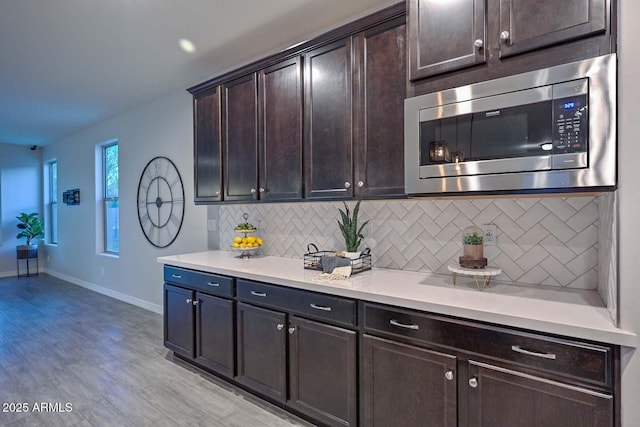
left=0, top=0, right=397, bottom=146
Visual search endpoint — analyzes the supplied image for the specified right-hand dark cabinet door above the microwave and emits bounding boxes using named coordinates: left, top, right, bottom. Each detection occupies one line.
left=495, top=0, right=607, bottom=57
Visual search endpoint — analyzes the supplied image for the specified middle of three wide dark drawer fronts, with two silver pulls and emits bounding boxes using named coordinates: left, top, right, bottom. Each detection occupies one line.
left=238, top=279, right=356, bottom=326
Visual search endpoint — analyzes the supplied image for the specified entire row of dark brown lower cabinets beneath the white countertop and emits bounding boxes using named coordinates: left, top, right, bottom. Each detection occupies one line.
left=164, top=267, right=620, bottom=427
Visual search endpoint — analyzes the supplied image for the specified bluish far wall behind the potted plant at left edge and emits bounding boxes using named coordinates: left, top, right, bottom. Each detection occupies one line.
left=0, top=144, right=42, bottom=277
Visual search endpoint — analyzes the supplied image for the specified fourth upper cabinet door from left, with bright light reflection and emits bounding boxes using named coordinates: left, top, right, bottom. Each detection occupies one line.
left=304, top=38, right=353, bottom=198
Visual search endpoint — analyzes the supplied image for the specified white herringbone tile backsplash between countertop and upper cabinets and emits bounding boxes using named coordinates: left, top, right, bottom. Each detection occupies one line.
left=220, top=196, right=598, bottom=290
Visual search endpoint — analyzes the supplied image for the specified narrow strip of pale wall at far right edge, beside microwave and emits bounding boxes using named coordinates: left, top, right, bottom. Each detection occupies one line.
left=618, top=0, right=640, bottom=427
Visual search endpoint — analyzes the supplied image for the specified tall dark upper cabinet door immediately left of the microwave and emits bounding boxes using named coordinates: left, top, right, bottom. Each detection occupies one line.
left=354, top=17, right=407, bottom=197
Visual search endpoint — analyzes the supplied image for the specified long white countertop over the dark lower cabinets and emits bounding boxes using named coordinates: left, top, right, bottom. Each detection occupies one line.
left=158, top=251, right=637, bottom=347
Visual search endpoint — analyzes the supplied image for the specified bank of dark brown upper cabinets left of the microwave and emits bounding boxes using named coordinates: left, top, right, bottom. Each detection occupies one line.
left=189, top=2, right=407, bottom=203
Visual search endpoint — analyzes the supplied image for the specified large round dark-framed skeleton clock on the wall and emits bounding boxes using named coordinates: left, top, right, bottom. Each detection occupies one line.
left=138, top=157, right=184, bottom=248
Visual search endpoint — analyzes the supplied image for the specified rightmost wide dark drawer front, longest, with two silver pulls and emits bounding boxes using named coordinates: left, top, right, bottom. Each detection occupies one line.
left=364, top=303, right=613, bottom=388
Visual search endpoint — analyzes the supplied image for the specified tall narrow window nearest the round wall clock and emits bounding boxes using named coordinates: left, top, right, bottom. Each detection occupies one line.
left=102, top=143, right=120, bottom=254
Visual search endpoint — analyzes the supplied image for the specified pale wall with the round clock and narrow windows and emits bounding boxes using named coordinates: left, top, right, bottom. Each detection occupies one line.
left=43, top=90, right=207, bottom=312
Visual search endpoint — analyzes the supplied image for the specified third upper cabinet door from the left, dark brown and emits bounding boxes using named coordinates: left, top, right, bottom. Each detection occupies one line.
left=258, top=57, right=302, bottom=200
